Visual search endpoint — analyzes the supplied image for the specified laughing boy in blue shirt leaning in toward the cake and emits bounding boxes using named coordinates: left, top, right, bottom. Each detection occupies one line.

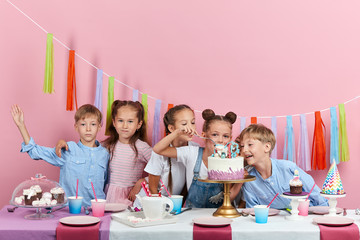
left=236, top=124, right=328, bottom=209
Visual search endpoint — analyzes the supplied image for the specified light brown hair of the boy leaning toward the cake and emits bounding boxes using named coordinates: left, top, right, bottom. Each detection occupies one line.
left=235, top=124, right=276, bottom=154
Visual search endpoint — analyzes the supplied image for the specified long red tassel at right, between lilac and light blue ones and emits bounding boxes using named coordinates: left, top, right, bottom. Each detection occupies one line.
left=311, top=111, right=326, bottom=170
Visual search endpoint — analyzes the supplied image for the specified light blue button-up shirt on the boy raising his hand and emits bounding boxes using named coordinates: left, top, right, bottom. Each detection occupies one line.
left=21, top=138, right=110, bottom=206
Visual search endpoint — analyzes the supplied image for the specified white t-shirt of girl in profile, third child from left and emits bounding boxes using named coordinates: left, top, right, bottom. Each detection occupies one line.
left=144, top=142, right=199, bottom=196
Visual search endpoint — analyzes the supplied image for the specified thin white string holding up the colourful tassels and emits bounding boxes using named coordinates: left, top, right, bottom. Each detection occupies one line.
left=6, top=0, right=360, bottom=119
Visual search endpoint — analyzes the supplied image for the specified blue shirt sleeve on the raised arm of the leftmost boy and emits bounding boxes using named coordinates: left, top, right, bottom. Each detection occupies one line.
left=20, top=137, right=65, bottom=167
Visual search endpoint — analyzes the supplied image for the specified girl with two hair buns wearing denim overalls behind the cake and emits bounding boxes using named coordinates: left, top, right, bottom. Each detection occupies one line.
left=153, top=109, right=241, bottom=208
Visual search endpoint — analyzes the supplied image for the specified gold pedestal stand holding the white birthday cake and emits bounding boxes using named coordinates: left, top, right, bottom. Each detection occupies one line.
left=198, top=175, right=256, bottom=218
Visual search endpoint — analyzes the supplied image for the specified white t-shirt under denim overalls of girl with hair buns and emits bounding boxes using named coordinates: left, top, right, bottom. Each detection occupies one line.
left=176, top=146, right=208, bottom=190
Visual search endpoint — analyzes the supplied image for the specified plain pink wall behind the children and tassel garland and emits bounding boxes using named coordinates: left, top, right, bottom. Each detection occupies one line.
left=0, top=0, right=360, bottom=208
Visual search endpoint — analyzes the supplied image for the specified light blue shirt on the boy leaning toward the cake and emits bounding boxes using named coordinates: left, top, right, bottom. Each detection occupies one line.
left=243, top=159, right=328, bottom=209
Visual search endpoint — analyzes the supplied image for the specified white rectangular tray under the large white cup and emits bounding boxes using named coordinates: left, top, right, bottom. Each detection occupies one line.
left=111, top=211, right=177, bottom=227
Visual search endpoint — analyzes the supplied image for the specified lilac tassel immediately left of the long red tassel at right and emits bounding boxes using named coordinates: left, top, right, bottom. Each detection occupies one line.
left=297, top=114, right=311, bottom=171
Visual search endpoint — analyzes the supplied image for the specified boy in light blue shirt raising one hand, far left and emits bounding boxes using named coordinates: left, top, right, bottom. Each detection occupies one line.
left=11, top=104, right=109, bottom=206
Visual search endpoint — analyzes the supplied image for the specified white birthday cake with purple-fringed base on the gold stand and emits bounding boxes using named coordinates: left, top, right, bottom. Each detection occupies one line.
left=208, top=142, right=244, bottom=180
